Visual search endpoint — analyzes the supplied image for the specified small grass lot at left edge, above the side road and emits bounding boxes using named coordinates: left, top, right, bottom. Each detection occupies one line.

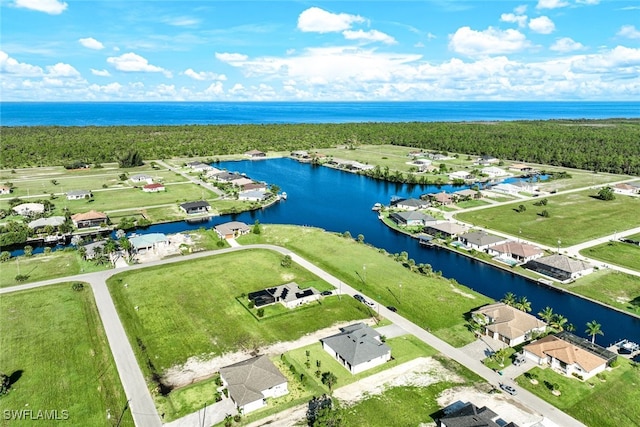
left=0, top=250, right=108, bottom=288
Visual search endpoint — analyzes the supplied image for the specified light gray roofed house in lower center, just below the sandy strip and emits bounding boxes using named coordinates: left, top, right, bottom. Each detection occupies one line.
left=320, top=323, right=391, bottom=366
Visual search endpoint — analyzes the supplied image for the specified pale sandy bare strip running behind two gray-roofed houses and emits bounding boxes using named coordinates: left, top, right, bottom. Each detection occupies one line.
left=162, top=319, right=374, bottom=388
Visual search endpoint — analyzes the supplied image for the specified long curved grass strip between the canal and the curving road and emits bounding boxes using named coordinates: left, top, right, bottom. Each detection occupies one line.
left=238, top=224, right=493, bottom=347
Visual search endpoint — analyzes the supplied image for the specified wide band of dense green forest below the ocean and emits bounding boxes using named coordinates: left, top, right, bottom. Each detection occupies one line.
left=0, top=119, right=640, bottom=175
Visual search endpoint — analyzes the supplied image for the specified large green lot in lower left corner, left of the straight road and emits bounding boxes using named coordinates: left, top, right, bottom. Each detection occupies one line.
left=0, top=283, right=134, bottom=426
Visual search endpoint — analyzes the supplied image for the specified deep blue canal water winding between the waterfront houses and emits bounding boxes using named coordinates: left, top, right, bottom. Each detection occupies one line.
left=119, top=158, right=640, bottom=345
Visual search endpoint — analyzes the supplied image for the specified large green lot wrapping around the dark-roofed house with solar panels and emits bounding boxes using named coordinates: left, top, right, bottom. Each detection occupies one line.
left=108, top=250, right=369, bottom=373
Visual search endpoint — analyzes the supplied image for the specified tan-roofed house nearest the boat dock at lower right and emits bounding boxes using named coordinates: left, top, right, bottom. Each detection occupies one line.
left=522, top=331, right=617, bottom=380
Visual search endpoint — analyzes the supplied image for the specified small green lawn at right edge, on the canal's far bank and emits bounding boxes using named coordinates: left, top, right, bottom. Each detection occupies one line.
left=562, top=270, right=640, bottom=316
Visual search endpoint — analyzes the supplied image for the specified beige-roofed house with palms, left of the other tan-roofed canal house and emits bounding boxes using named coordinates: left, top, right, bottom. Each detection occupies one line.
left=471, top=302, right=547, bottom=347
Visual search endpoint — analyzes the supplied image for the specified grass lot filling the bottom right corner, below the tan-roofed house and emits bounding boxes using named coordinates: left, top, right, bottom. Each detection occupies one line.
left=516, top=358, right=640, bottom=427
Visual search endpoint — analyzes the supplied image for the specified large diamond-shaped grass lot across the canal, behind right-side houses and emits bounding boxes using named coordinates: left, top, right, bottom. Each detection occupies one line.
left=455, top=190, right=640, bottom=247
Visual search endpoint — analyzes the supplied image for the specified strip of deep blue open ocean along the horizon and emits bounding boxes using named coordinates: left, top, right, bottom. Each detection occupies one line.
left=0, top=101, right=640, bottom=126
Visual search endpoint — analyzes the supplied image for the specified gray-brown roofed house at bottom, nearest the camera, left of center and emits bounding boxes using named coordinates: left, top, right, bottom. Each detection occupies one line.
left=220, top=355, right=287, bottom=406
